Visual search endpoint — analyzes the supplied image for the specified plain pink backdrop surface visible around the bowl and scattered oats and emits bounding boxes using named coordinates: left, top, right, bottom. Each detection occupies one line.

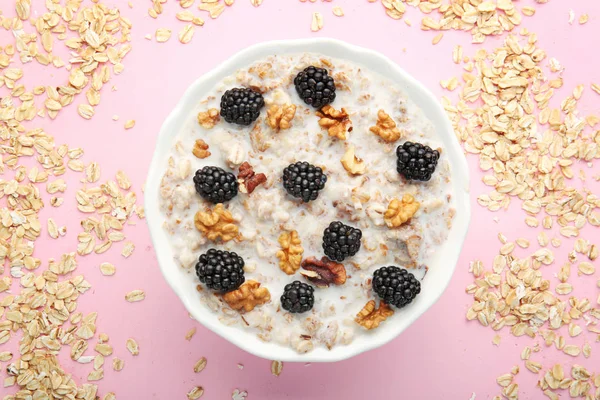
left=0, top=0, right=600, bottom=400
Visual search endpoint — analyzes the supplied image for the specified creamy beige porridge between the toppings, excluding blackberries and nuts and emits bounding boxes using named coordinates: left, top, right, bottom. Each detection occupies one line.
left=160, top=53, right=454, bottom=352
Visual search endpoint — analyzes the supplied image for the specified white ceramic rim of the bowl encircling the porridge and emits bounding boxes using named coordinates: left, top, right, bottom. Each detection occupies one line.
left=145, top=39, right=471, bottom=362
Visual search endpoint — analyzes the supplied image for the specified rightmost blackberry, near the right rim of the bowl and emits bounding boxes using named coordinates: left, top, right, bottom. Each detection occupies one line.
left=396, top=142, right=440, bottom=181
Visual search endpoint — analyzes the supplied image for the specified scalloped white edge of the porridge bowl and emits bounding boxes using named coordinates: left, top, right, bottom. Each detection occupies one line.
left=144, top=38, right=471, bottom=362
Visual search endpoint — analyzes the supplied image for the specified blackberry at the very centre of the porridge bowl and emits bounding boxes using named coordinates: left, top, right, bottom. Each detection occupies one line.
left=283, top=161, right=327, bottom=203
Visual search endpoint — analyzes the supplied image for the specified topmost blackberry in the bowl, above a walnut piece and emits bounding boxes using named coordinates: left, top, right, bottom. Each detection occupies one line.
left=294, top=65, right=335, bottom=108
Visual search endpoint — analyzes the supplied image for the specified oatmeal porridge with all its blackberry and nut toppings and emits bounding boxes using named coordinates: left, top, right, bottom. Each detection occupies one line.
left=160, top=53, right=454, bottom=352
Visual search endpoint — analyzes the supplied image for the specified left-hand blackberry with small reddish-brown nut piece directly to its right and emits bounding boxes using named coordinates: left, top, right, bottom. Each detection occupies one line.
left=194, top=166, right=239, bottom=204
